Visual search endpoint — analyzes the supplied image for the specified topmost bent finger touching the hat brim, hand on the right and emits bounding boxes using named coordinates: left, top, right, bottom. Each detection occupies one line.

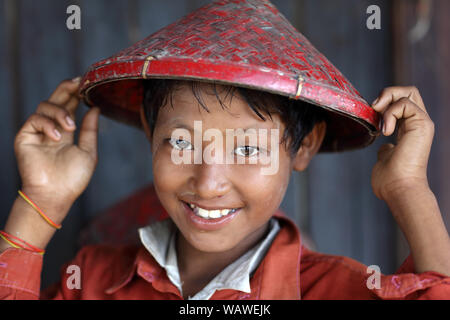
left=372, top=87, right=427, bottom=113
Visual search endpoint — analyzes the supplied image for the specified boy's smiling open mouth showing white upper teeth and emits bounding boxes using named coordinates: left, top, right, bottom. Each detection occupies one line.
left=181, top=201, right=242, bottom=231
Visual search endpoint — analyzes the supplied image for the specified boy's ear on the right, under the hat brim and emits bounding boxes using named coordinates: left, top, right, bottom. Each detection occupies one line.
left=293, top=121, right=327, bottom=171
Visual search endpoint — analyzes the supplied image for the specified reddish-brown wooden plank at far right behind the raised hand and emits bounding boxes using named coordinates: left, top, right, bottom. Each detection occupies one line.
left=393, top=0, right=450, bottom=264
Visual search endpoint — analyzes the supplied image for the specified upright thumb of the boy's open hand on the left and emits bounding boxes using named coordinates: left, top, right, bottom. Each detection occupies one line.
left=78, top=107, right=100, bottom=159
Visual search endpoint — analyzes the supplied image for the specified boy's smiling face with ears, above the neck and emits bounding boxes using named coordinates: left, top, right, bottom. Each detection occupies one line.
left=141, top=84, right=325, bottom=252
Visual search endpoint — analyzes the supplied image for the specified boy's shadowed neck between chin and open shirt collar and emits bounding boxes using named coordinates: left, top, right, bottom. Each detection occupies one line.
left=177, top=222, right=269, bottom=297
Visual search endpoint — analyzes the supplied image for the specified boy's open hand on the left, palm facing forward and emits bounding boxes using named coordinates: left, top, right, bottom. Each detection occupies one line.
left=14, top=79, right=100, bottom=221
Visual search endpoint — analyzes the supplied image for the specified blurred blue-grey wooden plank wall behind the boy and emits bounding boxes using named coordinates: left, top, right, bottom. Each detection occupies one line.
left=0, top=0, right=450, bottom=287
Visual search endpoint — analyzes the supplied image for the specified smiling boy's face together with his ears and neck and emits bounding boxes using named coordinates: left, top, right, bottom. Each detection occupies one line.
left=141, top=80, right=326, bottom=296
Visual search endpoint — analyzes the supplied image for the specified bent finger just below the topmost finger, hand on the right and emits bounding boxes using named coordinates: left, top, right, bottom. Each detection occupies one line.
left=383, top=98, right=433, bottom=136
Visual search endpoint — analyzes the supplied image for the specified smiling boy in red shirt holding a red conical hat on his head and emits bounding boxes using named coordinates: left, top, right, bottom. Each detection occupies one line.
left=0, top=0, right=450, bottom=299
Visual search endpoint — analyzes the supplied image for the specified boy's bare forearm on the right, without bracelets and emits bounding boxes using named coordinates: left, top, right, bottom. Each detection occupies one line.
left=386, top=186, right=450, bottom=276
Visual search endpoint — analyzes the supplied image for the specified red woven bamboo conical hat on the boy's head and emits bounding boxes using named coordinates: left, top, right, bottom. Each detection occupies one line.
left=80, top=0, right=380, bottom=152
